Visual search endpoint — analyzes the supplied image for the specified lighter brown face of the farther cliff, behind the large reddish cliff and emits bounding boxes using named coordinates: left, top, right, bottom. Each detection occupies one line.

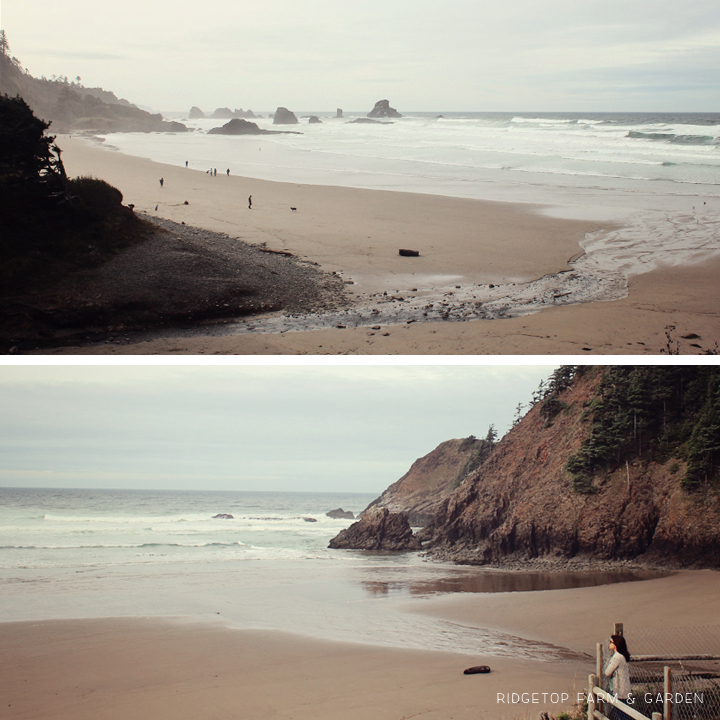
left=368, top=438, right=482, bottom=527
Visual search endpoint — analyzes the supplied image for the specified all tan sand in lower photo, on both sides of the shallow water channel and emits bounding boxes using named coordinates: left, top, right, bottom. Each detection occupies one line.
left=0, top=571, right=720, bottom=720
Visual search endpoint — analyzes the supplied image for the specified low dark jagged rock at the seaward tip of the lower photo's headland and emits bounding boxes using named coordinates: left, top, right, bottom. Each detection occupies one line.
left=328, top=508, right=420, bottom=551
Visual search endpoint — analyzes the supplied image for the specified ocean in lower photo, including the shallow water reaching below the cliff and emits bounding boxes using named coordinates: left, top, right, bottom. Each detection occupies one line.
left=0, top=488, right=664, bottom=660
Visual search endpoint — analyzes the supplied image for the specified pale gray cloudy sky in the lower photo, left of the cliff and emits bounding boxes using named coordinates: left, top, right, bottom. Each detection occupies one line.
left=0, top=365, right=556, bottom=494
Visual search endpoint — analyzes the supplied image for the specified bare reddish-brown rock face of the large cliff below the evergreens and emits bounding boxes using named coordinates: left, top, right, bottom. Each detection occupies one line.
left=422, top=369, right=720, bottom=567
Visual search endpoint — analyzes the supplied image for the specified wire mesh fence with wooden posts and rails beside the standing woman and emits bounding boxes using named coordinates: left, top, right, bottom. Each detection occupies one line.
left=602, top=625, right=720, bottom=720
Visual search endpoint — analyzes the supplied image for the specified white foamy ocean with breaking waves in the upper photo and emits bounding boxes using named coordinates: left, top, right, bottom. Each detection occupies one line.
left=105, top=112, right=720, bottom=219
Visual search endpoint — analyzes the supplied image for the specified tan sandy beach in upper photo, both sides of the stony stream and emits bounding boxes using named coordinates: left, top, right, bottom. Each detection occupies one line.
left=22, top=136, right=720, bottom=355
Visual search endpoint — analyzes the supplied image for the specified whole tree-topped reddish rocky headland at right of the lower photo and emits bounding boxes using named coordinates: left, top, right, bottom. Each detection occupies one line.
left=332, top=366, right=720, bottom=569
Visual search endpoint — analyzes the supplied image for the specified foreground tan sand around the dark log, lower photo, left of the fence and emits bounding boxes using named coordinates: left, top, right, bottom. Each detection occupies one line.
left=0, top=619, right=570, bottom=720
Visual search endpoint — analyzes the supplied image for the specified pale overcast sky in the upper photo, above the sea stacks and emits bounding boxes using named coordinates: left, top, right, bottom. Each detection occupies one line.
left=1, top=0, right=720, bottom=112
